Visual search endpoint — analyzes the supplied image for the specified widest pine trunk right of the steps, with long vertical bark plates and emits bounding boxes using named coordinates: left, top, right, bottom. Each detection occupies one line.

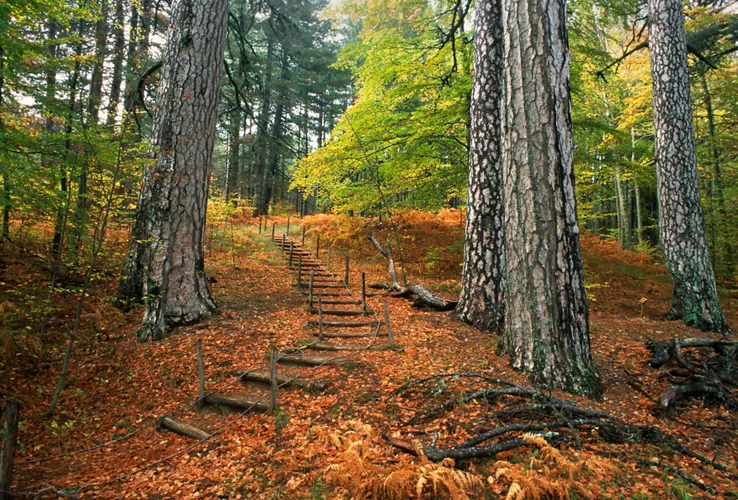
left=502, top=0, right=601, bottom=395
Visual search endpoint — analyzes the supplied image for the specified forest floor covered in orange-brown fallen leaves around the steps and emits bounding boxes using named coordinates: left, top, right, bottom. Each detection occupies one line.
left=0, top=211, right=738, bottom=500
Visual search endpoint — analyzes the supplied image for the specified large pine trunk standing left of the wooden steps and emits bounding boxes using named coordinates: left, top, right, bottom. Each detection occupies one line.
left=118, top=0, right=228, bottom=340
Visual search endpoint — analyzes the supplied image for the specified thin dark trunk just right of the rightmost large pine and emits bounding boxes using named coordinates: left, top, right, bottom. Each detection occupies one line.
left=701, top=75, right=734, bottom=276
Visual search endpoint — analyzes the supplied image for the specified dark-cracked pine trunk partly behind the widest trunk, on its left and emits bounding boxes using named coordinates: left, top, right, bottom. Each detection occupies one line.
left=456, top=0, right=504, bottom=331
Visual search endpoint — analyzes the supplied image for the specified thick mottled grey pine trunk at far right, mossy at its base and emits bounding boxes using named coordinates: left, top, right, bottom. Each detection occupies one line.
left=648, top=0, right=728, bottom=332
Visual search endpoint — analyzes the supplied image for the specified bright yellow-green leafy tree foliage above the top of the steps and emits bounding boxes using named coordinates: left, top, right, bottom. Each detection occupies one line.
left=292, top=1, right=472, bottom=214
